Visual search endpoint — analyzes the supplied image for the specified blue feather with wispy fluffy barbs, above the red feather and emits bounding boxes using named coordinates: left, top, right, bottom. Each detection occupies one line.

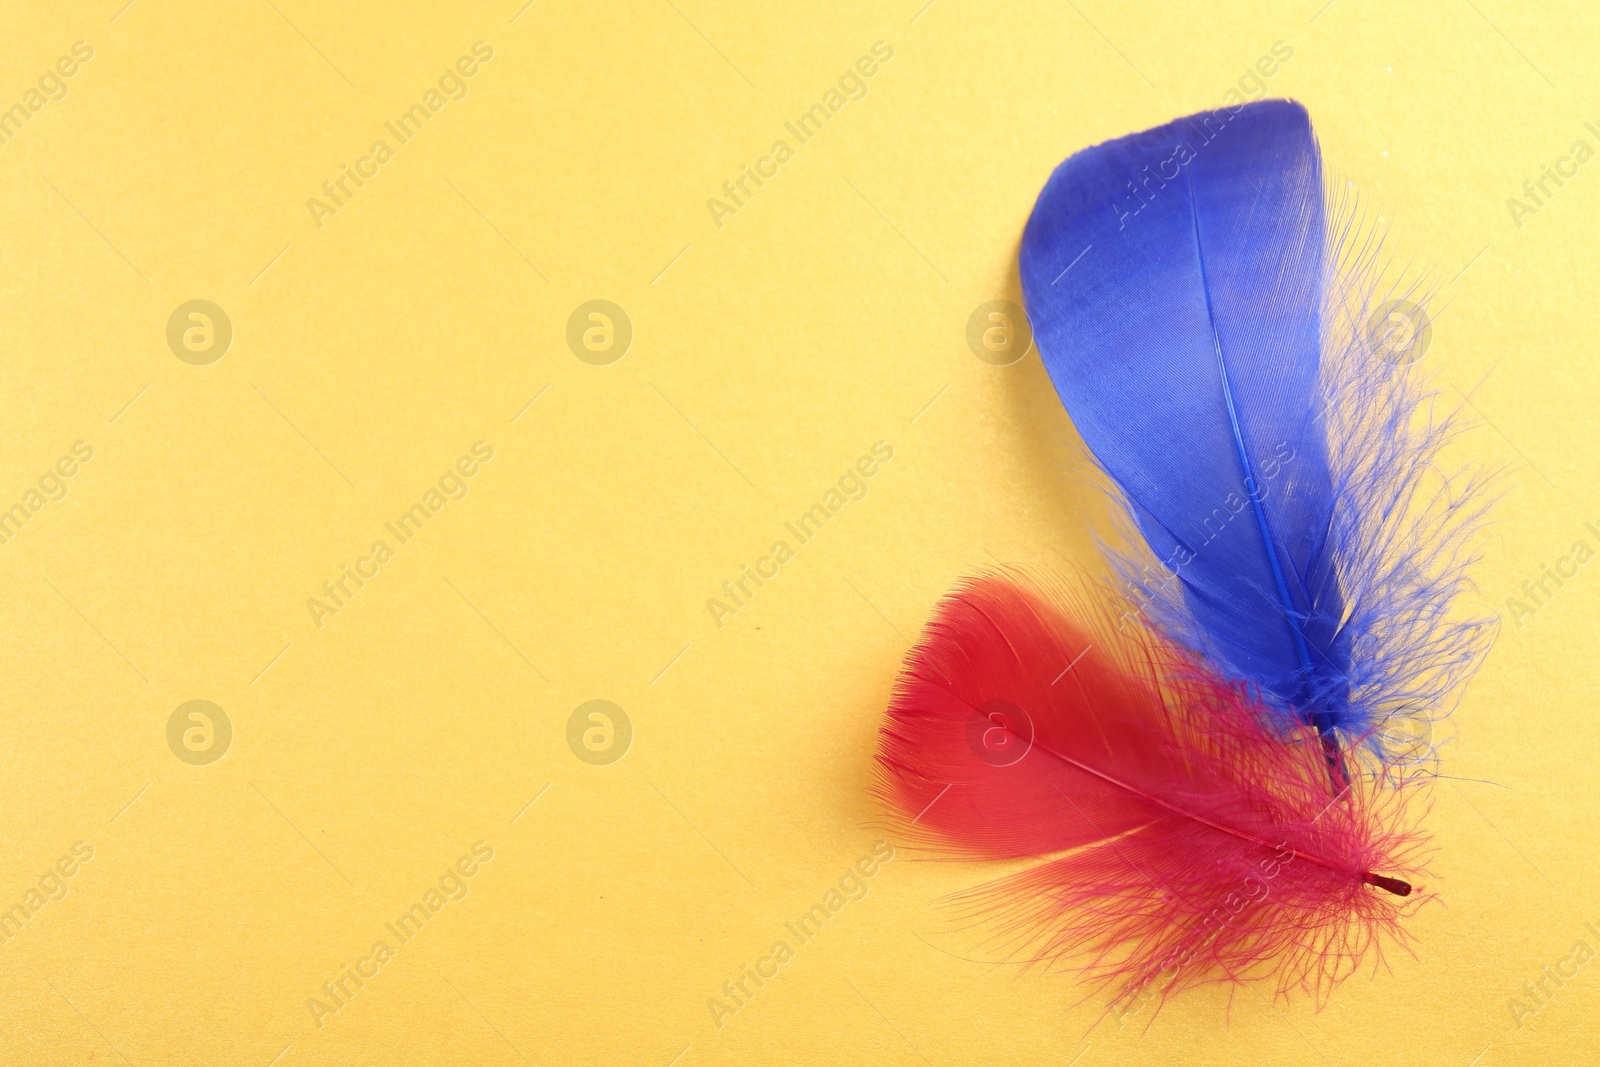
left=1019, top=99, right=1493, bottom=784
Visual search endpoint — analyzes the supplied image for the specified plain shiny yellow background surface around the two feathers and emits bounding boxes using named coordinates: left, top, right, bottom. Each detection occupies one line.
left=0, top=0, right=1600, bottom=1067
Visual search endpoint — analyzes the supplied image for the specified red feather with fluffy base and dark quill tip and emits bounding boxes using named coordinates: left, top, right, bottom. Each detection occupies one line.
left=877, top=573, right=1426, bottom=1009
